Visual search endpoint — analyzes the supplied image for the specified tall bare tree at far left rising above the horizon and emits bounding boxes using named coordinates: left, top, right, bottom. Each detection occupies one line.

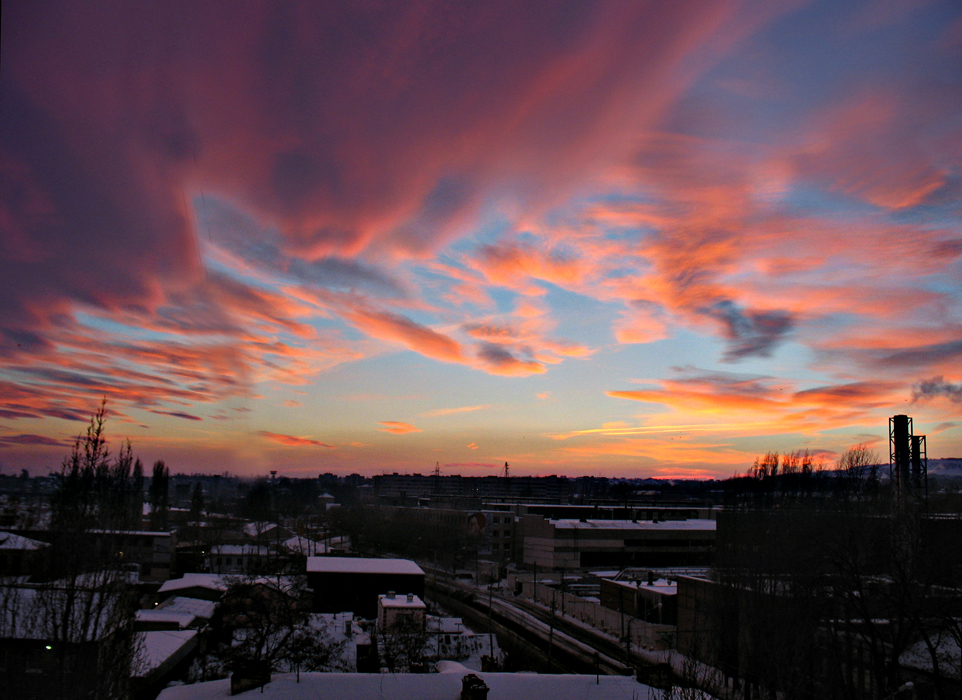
left=0, top=402, right=142, bottom=699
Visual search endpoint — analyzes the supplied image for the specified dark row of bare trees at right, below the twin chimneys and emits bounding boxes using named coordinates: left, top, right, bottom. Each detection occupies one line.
left=679, top=446, right=962, bottom=700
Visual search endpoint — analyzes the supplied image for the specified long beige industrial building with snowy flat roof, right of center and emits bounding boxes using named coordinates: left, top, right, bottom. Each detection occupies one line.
left=516, top=515, right=715, bottom=569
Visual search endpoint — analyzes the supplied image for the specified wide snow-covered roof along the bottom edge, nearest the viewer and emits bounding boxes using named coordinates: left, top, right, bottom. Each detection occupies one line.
left=158, top=661, right=661, bottom=700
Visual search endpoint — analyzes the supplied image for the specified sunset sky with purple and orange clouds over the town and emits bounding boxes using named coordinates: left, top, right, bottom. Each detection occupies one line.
left=0, top=0, right=962, bottom=478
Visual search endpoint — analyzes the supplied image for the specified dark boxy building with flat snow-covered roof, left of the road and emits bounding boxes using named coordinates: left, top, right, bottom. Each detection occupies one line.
left=307, top=557, right=424, bottom=620
